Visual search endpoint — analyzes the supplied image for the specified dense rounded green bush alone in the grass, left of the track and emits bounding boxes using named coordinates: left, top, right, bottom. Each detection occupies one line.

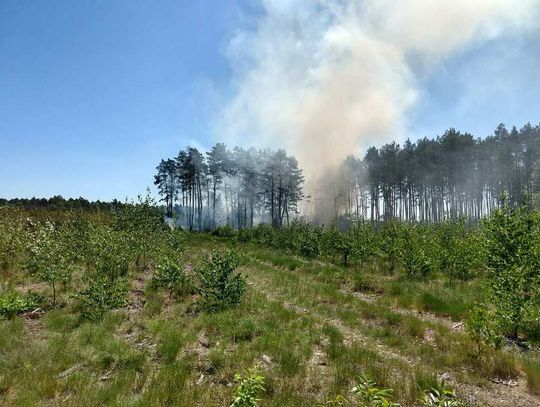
left=195, top=249, right=246, bottom=311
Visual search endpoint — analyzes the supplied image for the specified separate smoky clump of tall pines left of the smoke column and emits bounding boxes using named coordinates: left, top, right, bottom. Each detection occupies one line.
left=154, top=143, right=304, bottom=230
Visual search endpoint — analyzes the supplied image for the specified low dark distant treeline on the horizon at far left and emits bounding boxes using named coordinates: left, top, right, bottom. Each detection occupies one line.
left=0, top=195, right=124, bottom=212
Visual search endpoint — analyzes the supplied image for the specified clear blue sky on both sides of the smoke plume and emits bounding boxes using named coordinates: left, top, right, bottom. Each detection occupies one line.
left=0, top=0, right=540, bottom=200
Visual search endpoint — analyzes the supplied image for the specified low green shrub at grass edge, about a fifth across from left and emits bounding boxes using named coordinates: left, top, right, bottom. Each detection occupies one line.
left=77, top=273, right=127, bottom=321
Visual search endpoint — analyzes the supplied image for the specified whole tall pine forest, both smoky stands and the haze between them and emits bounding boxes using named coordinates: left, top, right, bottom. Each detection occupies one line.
left=155, top=123, right=540, bottom=230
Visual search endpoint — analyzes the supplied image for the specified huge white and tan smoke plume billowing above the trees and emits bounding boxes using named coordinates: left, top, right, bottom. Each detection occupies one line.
left=218, top=0, right=540, bottom=190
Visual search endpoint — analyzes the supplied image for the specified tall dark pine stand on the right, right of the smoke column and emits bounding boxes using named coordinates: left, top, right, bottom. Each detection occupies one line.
left=338, top=123, right=540, bottom=222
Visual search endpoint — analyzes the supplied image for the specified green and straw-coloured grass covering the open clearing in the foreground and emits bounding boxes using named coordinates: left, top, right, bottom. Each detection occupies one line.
left=0, top=231, right=540, bottom=406
